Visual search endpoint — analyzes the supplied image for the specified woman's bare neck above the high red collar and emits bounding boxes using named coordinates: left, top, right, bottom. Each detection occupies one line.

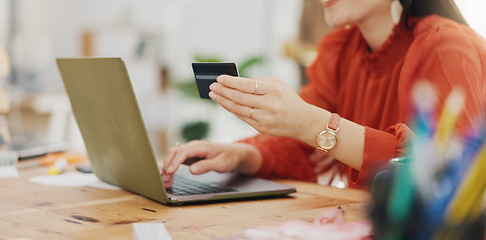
left=357, top=14, right=395, bottom=51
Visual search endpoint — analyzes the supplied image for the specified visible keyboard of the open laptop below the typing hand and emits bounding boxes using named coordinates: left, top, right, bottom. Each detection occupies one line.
left=167, top=175, right=236, bottom=196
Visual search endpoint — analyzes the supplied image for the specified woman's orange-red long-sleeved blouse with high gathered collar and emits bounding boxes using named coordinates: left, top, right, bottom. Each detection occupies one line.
left=242, top=15, right=486, bottom=187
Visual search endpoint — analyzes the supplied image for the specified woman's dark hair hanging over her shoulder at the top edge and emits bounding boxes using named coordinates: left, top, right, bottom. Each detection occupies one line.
left=400, top=0, right=468, bottom=26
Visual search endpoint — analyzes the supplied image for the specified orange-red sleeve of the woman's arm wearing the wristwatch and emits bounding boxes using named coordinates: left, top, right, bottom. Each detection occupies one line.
left=351, top=17, right=486, bottom=184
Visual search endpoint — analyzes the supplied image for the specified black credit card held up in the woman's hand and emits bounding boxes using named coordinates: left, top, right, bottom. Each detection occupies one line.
left=192, top=63, right=238, bottom=99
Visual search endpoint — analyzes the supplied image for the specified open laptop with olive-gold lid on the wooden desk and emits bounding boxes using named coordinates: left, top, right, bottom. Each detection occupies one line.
left=57, top=58, right=296, bottom=204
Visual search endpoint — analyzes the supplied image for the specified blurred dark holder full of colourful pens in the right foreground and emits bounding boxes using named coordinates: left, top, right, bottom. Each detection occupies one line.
left=370, top=82, right=486, bottom=239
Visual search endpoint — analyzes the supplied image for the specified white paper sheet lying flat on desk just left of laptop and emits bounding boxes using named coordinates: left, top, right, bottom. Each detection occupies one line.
left=29, top=172, right=121, bottom=190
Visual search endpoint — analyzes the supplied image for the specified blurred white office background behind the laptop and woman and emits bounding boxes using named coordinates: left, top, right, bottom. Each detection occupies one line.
left=0, top=0, right=486, bottom=158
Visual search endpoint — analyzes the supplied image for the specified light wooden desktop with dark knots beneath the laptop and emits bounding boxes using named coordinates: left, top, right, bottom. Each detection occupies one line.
left=0, top=160, right=369, bottom=240
